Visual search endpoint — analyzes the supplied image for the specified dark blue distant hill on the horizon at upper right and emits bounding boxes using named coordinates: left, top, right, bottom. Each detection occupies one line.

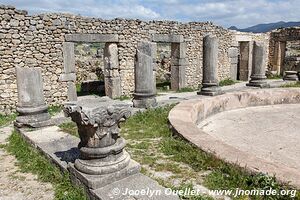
left=229, top=21, right=300, bottom=33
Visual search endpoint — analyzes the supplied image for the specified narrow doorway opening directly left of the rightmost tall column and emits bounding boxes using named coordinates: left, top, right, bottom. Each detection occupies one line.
left=236, top=42, right=250, bottom=81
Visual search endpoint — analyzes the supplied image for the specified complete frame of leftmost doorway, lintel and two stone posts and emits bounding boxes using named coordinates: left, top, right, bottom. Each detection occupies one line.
left=60, top=34, right=121, bottom=101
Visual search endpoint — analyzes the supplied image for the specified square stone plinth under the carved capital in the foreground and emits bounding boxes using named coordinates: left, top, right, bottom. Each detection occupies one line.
left=68, top=160, right=141, bottom=189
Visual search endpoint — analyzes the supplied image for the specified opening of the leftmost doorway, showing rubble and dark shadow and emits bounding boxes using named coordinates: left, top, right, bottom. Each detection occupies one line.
left=74, top=42, right=106, bottom=96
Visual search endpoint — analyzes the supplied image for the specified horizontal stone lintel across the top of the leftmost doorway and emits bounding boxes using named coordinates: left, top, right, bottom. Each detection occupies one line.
left=65, top=34, right=119, bottom=42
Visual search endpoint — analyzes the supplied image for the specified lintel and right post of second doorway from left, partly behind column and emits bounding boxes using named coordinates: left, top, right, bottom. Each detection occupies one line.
left=151, top=34, right=188, bottom=90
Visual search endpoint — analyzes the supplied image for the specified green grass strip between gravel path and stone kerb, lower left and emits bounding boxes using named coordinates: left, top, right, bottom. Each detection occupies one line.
left=4, top=131, right=87, bottom=200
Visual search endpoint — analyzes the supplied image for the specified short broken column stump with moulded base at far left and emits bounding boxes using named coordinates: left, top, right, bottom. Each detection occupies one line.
left=15, top=67, right=51, bottom=128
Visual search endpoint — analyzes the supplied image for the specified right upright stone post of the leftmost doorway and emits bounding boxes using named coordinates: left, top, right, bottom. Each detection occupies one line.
left=104, top=43, right=121, bottom=98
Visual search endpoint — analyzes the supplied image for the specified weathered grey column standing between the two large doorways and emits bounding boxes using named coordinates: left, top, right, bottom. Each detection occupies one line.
left=133, top=42, right=156, bottom=108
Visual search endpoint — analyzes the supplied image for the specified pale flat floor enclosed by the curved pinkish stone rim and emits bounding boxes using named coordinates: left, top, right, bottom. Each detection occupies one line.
left=198, top=104, right=300, bottom=170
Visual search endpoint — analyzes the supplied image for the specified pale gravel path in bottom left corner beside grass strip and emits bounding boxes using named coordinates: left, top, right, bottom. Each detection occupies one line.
left=0, top=126, right=54, bottom=200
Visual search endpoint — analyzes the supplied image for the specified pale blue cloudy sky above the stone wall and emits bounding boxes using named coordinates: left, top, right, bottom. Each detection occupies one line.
left=0, top=0, right=300, bottom=28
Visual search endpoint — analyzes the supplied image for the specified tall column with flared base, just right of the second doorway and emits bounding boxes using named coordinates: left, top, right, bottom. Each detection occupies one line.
left=198, top=35, right=223, bottom=96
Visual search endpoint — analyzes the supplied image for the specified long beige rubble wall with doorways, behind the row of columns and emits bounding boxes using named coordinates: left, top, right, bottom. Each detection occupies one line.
left=0, top=6, right=268, bottom=113
